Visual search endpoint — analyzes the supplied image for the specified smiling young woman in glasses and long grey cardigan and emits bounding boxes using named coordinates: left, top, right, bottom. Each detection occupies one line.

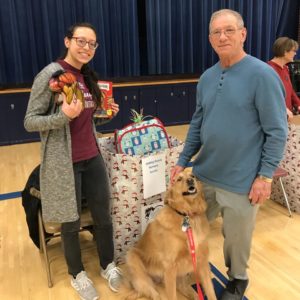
left=24, top=23, right=122, bottom=300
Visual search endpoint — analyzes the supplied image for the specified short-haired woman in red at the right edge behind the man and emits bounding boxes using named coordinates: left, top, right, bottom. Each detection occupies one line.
left=268, top=37, right=300, bottom=120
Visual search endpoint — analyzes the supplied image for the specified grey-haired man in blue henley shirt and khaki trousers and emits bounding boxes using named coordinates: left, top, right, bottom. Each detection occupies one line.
left=171, top=9, right=287, bottom=300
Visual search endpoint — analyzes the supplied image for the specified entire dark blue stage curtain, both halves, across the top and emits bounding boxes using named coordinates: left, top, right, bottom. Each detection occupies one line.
left=0, top=0, right=300, bottom=88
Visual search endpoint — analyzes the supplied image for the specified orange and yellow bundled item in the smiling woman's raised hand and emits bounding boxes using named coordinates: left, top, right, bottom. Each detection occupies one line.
left=49, top=70, right=84, bottom=107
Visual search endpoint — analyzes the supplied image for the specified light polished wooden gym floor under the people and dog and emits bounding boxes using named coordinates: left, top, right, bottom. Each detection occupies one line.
left=0, top=126, right=300, bottom=300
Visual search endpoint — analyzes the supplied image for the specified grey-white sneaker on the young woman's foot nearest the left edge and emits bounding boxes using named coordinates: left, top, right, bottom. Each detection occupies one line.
left=71, top=271, right=99, bottom=300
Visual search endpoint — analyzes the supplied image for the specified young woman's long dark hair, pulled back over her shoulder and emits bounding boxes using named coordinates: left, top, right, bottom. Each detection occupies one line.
left=60, top=22, right=101, bottom=106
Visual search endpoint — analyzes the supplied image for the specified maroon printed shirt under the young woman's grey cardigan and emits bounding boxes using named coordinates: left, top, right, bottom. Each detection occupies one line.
left=58, top=60, right=99, bottom=162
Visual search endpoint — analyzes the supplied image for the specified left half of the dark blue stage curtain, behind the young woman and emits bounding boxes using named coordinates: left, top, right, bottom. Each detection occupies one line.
left=0, top=0, right=140, bottom=86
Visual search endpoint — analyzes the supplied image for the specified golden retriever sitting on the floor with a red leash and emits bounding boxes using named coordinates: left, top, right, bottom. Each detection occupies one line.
left=120, top=170, right=216, bottom=300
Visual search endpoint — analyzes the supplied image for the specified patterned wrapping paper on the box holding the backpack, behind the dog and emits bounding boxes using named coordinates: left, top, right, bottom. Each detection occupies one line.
left=98, top=136, right=184, bottom=263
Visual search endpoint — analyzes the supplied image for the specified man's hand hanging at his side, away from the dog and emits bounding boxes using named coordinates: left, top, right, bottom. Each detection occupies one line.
left=249, top=178, right=272, bottom=205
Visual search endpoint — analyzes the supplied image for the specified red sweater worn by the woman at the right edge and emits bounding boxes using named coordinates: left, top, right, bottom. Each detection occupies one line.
left=268, top=61, right=300, bottom=111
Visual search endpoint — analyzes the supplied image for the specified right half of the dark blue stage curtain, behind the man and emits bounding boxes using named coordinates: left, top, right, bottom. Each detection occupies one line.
left=146, top=0, right=300, bottom=74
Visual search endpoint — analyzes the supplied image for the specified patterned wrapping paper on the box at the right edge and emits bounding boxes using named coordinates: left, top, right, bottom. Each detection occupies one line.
left=271, top=124, right=300, bottom=212
